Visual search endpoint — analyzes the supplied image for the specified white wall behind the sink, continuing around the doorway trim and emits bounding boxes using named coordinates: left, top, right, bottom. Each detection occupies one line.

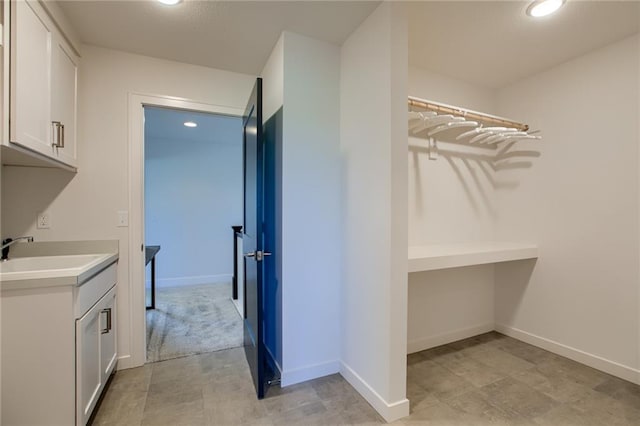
left=2, top=46, right=255, bottom=367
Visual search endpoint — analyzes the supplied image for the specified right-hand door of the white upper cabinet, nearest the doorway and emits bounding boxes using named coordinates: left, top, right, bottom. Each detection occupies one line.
left=51, top=36, right=78, bottom=167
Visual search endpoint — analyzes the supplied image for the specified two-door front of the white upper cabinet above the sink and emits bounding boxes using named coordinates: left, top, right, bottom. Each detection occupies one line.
left=5, top=1, right=78, bottom=168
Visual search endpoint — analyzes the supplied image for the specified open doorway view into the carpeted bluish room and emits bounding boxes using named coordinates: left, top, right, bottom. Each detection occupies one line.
left=143, top=106, right=243, bottom=362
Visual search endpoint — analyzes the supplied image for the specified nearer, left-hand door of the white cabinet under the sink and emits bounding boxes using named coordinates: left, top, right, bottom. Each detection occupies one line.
left=76, top=303, right=102, bottom=425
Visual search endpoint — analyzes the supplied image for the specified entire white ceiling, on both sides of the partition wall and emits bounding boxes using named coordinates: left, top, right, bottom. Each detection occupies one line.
left=60, top=0, right=640, bottom=88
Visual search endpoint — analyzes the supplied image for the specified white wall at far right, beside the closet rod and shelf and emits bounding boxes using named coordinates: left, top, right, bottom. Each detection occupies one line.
left=496, top=36, right=640, bottom=382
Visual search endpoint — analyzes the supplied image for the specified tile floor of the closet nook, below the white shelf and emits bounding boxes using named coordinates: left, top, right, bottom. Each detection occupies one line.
left=400, top=333, right=640, bottom=426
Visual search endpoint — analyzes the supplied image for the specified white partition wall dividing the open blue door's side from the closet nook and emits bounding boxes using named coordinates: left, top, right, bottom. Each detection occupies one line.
left=340, top=3, right=409, bottom=421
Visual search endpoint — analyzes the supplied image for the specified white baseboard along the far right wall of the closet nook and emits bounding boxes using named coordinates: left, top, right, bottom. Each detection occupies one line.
left=495, top=324, right=640, bottom=385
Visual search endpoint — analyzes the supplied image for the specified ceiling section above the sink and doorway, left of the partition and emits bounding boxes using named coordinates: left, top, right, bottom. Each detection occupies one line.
left=59, top=0, right=380, bottom=75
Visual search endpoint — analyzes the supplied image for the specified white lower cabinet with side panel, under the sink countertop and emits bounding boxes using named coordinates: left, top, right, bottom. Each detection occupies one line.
left=0, top=263, right=117, bottom=426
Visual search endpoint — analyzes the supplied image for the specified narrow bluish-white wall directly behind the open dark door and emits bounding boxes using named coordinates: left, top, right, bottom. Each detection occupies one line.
left=281, top=33, right=342, bottom=385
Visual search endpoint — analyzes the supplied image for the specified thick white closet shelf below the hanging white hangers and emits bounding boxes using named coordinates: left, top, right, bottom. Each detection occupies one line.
left=409, top=242, right=538, bottom=273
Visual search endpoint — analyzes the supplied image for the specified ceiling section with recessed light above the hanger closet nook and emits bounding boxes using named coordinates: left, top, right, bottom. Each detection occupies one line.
left=409, top=0, right=640, bottom=88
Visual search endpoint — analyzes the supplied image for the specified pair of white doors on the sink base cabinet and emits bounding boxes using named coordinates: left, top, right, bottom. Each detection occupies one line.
left=76, top=287, right=116, bottom=425
